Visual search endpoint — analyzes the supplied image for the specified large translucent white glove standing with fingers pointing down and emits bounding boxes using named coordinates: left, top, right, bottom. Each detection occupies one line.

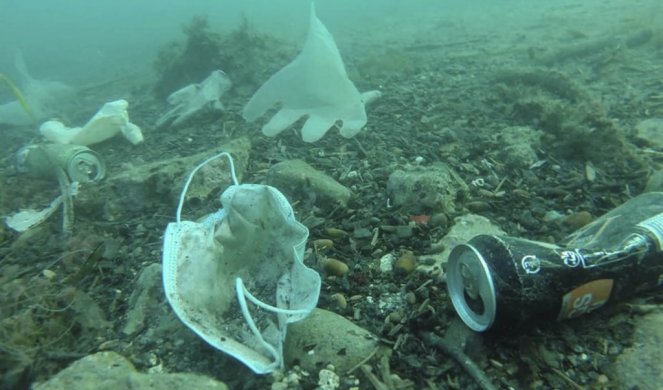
left=243, top=4, right=380, bottom=142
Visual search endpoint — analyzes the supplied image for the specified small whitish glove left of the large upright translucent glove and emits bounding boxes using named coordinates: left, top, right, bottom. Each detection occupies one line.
left=156, top=70, right=232, bottom=127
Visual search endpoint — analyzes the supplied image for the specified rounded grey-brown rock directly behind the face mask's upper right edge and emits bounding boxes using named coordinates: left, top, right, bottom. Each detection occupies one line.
left=267, top=160, right=352, bottom=207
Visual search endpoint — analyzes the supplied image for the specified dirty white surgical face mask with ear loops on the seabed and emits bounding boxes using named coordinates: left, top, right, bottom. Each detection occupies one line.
left=163, top=153, right=321, bottom=374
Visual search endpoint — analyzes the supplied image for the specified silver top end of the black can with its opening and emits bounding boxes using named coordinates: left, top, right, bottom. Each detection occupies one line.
left=447, top=244, right=497, bottom=332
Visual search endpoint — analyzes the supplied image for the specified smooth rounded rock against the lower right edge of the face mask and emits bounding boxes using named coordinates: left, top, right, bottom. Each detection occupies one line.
left=284, top=309, right=378, bottom=373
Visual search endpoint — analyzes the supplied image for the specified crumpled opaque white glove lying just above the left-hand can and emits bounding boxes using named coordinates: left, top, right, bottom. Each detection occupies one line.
left=39, top=99, right=143, bottom=146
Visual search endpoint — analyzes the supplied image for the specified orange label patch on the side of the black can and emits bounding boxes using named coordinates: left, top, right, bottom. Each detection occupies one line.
left=557, top=279, right=613, bottom=320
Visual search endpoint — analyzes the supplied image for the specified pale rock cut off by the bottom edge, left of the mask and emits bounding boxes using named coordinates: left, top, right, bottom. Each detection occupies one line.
left=33, top=352, right=228, bottom=390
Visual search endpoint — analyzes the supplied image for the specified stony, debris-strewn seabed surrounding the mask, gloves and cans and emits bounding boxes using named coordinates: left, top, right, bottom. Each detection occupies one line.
left=0, top=1, right=663, bottom=389
